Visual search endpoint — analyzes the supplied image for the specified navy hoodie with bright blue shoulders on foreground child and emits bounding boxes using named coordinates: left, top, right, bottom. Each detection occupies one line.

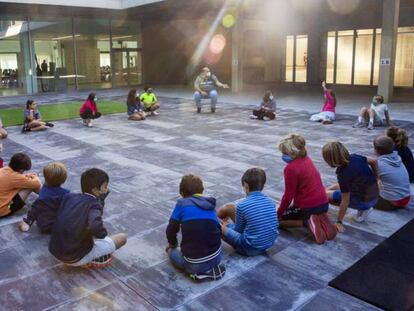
left=166, top=195, right=221, bottom=263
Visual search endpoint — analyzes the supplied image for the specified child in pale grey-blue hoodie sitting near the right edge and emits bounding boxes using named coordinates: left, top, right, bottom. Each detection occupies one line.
left=374, top=136, right=411, bottom=211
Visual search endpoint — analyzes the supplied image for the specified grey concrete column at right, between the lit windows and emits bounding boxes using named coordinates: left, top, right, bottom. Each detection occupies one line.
left=378, top=0, right=400, bottom=103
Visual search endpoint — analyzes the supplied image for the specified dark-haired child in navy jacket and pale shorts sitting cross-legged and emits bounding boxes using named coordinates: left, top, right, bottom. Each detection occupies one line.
left=49, top=168, right=127, bottom=267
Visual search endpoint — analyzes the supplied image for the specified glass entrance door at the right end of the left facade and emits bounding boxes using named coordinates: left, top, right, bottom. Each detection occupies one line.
left=112, top=49, right=142, bottom=87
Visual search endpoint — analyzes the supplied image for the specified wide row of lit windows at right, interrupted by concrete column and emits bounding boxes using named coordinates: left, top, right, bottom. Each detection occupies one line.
left=326, top=27, right=414, bottom=87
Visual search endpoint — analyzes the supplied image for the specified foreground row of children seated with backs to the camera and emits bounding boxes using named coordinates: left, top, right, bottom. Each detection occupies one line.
left=0, top=123, right=414, bottom=280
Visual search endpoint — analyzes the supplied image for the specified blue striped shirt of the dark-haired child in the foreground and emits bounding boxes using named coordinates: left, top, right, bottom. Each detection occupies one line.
left=234, top=191, right=279, bottom=250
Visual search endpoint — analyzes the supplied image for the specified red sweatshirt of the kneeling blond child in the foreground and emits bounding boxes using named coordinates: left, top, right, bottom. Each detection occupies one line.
left=277, top=157, right=328, bottom=218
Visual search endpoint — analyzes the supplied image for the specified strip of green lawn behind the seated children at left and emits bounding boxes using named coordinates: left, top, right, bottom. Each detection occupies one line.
left=0, top=101, right=126, bottom=126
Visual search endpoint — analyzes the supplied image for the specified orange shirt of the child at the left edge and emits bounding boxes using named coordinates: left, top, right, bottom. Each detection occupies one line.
left=0, top=166, right=41, bottom=216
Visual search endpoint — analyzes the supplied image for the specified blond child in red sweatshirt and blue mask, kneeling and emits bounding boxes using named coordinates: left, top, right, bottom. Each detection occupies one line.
left=277, top=134, right=337, bottom=244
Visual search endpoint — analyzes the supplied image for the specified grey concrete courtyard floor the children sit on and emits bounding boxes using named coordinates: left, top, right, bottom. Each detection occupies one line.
left=0, top=98, right=414, bottom=311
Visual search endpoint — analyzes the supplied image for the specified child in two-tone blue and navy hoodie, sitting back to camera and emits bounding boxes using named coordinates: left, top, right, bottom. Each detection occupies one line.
left=166, top=175, right=226, bottom=280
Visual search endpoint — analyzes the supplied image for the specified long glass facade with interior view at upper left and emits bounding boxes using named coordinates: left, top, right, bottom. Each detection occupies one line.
left=0, top=16, right=143, bottom=95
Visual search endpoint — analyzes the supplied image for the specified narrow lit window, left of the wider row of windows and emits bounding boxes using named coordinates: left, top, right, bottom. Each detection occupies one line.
left=285, top=35, right=308, bottom=82
